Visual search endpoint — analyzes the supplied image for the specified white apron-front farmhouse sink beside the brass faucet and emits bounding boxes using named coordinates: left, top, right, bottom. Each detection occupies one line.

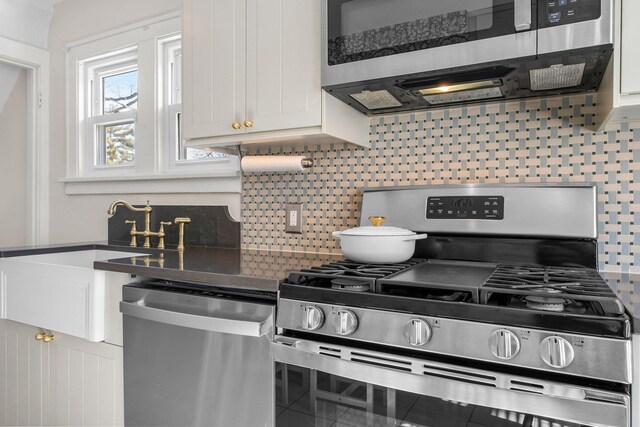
left=0, top=250, right=140, bottom=342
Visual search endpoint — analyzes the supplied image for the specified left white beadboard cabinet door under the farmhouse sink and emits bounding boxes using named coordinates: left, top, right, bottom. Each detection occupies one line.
left=0, top=320, right=51, bottom=426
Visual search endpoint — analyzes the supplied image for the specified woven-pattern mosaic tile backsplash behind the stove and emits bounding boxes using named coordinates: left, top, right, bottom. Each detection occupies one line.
left=242, top=95, right=640, bottom=273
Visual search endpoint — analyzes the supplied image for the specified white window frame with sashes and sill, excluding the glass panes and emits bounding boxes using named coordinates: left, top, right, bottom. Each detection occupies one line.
left=59, top=12, right=241, bottom=194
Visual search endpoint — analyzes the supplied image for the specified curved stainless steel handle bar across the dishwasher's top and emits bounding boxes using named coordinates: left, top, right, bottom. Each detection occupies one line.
left=120, top=301, right=273, bottom=337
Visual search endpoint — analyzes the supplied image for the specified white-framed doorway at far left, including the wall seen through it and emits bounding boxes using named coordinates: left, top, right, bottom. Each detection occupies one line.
left=0, top=37, right=49, bottom=248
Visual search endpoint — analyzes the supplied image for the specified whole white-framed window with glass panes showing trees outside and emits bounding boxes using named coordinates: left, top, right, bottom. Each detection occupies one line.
left=63, top=14, right=239, bottom=193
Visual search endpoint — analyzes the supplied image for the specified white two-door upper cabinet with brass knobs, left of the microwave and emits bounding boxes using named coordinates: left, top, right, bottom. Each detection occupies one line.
left=182, top=0, right=369, bottom=147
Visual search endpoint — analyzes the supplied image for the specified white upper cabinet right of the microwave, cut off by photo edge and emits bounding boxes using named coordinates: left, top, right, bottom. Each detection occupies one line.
left=596, top=0, right=640, bottom=130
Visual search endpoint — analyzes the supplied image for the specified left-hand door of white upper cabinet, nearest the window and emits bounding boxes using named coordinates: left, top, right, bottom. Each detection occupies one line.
left=182, top=0, right=246, bottom=139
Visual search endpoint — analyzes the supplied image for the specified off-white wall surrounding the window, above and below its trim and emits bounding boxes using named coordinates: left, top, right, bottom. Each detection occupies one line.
left=49, top=0, right=240, bottom=243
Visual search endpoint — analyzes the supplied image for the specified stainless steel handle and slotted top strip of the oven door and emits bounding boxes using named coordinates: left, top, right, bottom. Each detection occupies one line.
left=271, top=336, right=631, bottom=427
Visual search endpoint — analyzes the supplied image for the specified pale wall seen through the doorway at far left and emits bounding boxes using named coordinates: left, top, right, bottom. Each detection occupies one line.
left=0, top=67, right=27, bottom=247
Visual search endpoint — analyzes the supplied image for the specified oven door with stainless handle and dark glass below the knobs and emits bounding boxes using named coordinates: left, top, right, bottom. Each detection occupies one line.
left=271, top=336, right=630, bottom=427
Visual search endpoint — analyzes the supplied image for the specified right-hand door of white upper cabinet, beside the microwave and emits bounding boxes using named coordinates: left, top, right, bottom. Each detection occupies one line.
left=246, top=0, right=322, bottom=132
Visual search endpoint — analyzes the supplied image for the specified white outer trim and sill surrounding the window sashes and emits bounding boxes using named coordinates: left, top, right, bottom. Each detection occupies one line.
left=59, top=12, right=241, bottom=194
